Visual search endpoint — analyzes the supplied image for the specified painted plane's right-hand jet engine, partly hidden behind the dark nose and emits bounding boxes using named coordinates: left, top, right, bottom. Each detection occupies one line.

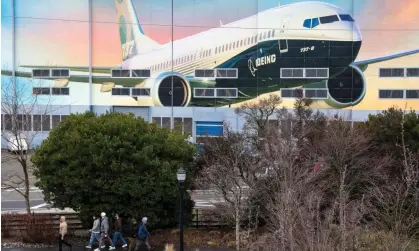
left=326, top=65, right=366, bottom=108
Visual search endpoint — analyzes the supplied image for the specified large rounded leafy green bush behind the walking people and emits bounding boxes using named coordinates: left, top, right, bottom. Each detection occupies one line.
left=32, top=112, right=195, bottom=227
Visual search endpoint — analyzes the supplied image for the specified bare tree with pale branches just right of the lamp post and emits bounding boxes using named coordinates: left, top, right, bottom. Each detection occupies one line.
left=197, top=127, right=257, bottom=250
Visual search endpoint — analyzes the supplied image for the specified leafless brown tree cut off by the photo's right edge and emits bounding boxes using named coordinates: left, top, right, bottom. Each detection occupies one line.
left=372, top=107, right=419, bottom=250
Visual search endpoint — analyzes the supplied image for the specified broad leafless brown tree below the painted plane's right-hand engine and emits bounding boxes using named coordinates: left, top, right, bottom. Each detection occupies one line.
left=310, top=119, right=388, bottom=250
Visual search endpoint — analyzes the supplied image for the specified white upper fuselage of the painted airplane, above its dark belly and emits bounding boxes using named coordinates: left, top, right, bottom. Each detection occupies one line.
left=120, top=2, right=362, bottom=76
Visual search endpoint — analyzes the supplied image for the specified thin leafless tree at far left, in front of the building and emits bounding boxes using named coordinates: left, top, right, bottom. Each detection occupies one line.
left=1, top=77, right=55, bottom=213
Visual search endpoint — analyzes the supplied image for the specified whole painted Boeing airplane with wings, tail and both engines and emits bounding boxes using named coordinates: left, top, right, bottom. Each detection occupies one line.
left=2, top=0, right=419, bottom=108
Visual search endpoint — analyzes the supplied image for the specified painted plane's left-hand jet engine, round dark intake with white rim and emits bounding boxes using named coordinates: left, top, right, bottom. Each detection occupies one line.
left=142, top=72, right=192, bottom=106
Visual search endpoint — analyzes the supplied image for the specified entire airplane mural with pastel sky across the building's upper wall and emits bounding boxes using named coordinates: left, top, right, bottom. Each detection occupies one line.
left=1, top=0, right=419, bottom=110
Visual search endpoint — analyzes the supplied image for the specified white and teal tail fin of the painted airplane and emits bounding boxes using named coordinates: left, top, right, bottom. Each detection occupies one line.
left=114, top=0, right=160, bottom=60
